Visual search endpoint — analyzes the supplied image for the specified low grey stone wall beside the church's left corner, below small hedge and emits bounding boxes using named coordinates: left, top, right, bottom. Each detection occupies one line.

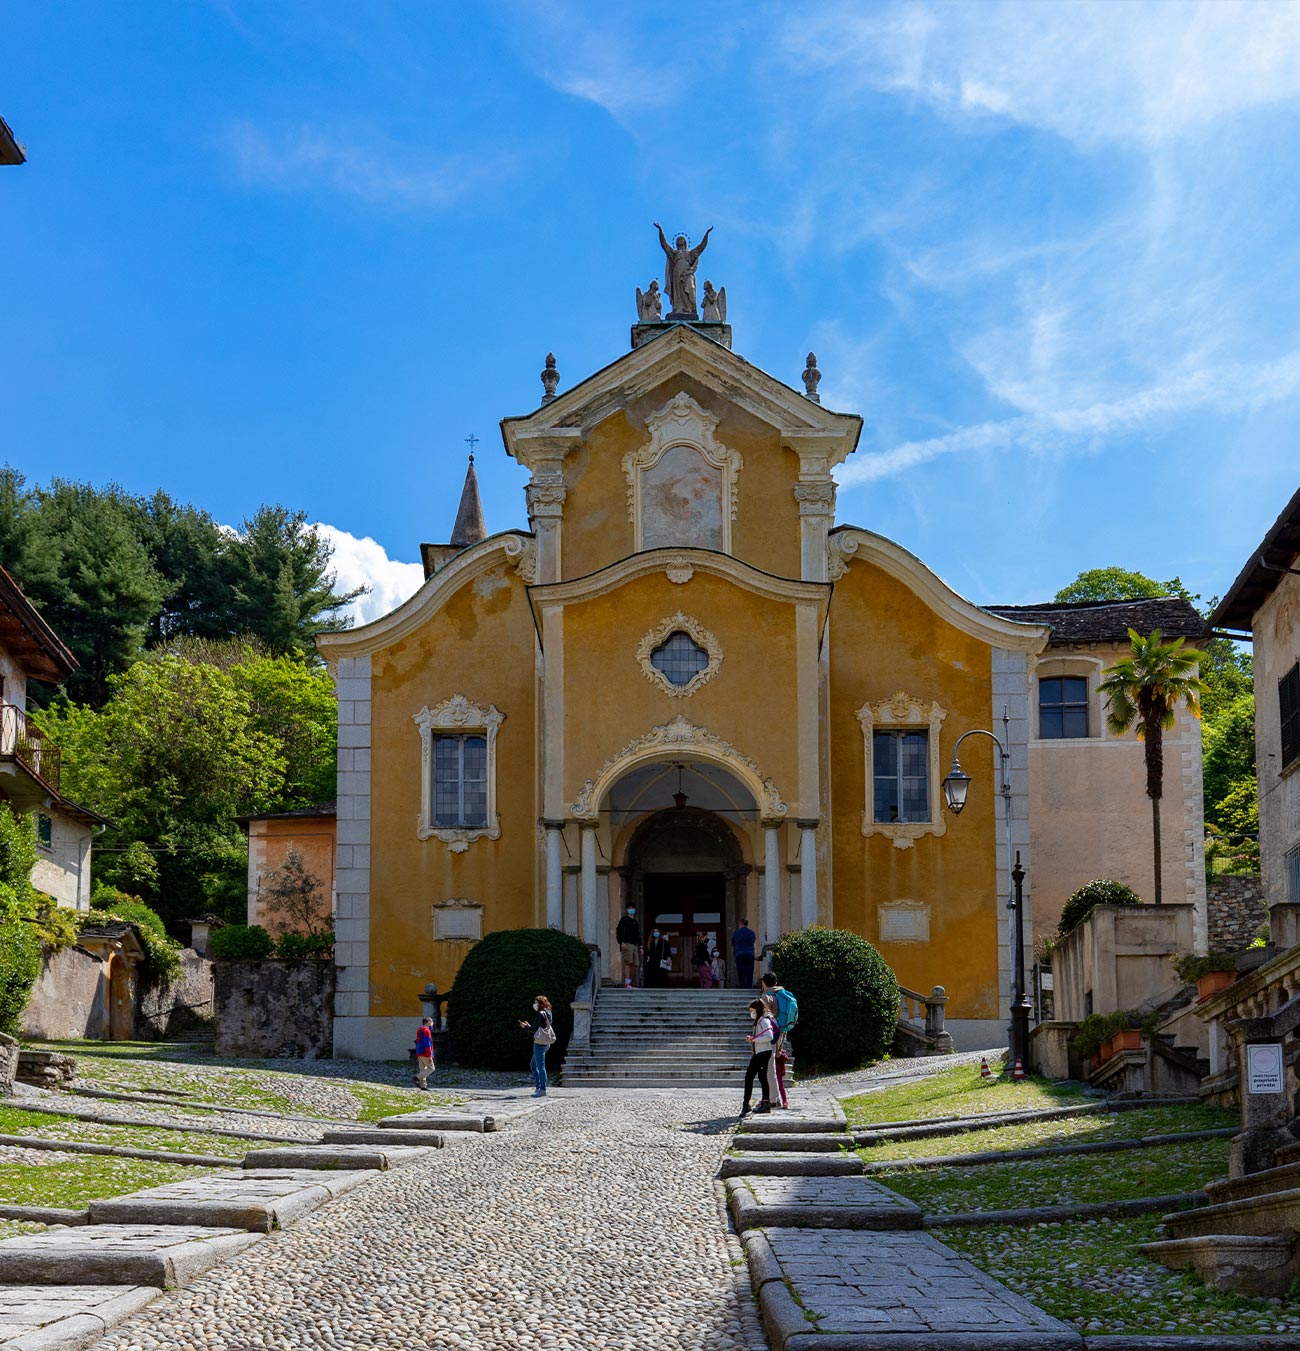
left=214, top=959, right=334, bottom=1059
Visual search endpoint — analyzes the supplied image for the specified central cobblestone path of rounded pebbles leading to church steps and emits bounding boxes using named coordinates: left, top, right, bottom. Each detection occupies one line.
left=97, top=1093, right=764, bottom=1351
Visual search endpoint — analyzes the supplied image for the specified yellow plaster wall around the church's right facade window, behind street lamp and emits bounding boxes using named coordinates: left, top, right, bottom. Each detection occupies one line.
left=830, top=562, right=999, bottom=1019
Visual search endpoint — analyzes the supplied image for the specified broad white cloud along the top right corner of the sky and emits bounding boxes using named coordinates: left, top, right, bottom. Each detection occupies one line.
left=781, top=0, right=1300, bottom=145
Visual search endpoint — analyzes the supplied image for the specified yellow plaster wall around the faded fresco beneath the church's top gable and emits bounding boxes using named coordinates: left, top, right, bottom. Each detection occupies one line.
left=561, top=376, right=799, bottom=578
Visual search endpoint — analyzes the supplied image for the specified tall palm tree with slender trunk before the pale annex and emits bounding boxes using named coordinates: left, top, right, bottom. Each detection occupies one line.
left=1097, top=628, right=1204, bottom=905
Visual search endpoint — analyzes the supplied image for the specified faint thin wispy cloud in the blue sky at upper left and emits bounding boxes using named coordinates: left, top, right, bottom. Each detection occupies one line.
left=227, top=122, right=511, bottom=211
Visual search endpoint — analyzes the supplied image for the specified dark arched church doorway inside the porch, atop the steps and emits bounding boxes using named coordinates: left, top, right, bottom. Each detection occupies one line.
left=620, top=807, right=750, bottom=989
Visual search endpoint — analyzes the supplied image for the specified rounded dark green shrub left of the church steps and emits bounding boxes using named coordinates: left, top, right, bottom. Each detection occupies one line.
left=447, top=929, right=591, bottom=1070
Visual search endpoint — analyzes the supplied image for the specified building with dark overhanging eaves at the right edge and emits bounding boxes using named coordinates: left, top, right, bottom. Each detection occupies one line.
left=1209, top=480, right=1300, bottom=908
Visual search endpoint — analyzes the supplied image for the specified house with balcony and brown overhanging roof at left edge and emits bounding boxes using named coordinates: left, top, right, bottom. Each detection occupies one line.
left=0, top=567, right=107, bottom=911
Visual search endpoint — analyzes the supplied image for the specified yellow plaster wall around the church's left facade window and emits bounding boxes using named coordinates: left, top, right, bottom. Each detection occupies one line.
left=370, top=565, right=538, bottom=1016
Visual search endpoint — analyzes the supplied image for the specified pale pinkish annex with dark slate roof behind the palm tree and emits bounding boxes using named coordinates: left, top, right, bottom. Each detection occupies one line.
left=991, top=596, right=1207, bottom=952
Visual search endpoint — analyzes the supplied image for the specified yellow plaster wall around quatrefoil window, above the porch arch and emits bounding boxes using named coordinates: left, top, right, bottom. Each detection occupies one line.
left=564, top=571, right=797, bottom=802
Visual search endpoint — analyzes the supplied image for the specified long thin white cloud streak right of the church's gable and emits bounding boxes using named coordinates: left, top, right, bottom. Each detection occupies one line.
left=839, top=351, right=1300, bottom=488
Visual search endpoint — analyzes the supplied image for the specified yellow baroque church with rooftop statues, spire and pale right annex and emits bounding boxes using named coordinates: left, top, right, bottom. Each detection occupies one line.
left=318, top=231, right=1205, bottom=1058
